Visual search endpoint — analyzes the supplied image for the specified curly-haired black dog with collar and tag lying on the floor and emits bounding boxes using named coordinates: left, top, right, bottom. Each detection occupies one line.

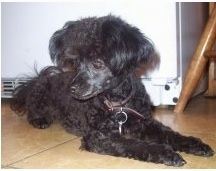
left=11, top=15, right=214, bottom=166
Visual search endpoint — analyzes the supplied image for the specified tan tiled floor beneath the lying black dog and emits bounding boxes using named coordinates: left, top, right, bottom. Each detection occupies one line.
left=1, top=96, right=216, bottom=169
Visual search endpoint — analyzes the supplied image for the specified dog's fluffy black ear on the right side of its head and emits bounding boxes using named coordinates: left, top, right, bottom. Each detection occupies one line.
left=102, top=16, right=154, bottom=73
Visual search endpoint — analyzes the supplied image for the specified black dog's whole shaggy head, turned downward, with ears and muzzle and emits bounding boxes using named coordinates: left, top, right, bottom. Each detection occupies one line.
left=49, top=15, right=157, bottom=100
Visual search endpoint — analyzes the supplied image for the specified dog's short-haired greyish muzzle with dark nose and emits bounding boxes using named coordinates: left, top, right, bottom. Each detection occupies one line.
left=70, top=62, right=114, bottom=100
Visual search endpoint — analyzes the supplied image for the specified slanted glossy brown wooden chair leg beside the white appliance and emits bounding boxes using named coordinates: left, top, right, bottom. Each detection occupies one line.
left=174, top=7, right=216, bottom=113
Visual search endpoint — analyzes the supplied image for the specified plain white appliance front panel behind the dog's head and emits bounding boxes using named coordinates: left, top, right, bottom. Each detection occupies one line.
left=1, top=0, right=177, bottom=77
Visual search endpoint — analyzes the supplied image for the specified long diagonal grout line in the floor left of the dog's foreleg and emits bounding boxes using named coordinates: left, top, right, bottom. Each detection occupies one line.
left=4, top=137, right=80, bottom=168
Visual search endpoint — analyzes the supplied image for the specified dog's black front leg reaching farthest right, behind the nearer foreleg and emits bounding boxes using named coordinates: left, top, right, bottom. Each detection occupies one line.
left=145, top=120, right=214, bottom=156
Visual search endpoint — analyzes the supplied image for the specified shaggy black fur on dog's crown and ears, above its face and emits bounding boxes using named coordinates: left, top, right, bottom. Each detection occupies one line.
left=49, top=16, right=154, bottom=74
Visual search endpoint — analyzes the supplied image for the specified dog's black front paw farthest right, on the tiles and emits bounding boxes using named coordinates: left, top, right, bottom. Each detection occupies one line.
left=185, top=137, right=214, bottom=157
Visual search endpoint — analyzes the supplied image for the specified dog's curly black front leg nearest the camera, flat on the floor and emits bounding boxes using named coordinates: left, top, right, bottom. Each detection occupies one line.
left=81, top=130, right=186, bottom=166
